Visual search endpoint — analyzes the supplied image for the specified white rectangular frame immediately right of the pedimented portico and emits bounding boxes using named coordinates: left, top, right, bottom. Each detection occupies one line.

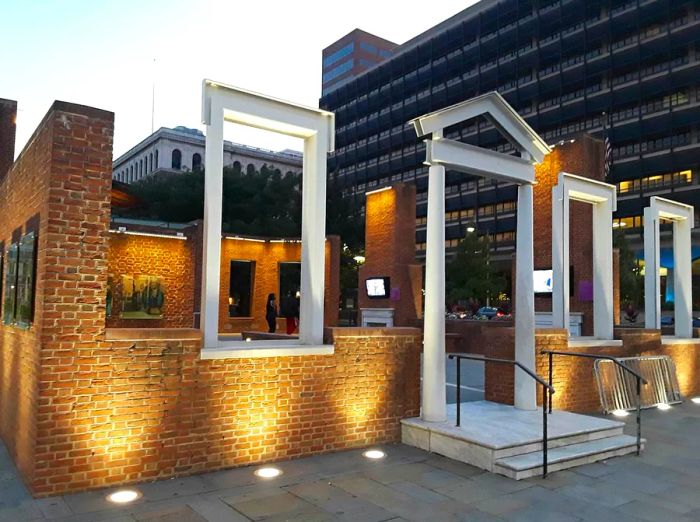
left=552, top=172, right=617, bottom=340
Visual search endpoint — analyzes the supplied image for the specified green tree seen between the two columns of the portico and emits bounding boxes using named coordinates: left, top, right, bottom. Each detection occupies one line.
left=445, top=231, right=506, bottom=303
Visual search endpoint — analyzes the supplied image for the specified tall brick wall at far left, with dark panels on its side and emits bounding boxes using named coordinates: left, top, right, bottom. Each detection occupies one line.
left=0, top=101, right=114, bottom=492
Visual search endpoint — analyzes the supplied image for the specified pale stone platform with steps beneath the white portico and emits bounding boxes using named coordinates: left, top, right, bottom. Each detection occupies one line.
left=401, top=401, right=636, bottom=480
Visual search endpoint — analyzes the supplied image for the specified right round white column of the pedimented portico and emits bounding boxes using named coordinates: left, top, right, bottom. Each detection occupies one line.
left=515, top=181, right=537, bottom=410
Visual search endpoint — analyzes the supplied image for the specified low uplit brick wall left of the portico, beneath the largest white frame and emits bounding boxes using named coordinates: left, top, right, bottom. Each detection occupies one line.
left=30, top=328, right=421, bottom=496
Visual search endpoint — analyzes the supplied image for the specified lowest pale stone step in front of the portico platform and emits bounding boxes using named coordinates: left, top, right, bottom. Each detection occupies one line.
left=493, top=435, right=645, bottom=480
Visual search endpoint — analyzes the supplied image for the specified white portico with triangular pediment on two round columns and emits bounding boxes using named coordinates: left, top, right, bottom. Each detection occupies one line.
left=412, top=92, right=550, bottom=414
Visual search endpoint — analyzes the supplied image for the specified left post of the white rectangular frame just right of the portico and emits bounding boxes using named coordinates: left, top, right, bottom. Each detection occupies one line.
left=552, top=181, right=570, bottom=332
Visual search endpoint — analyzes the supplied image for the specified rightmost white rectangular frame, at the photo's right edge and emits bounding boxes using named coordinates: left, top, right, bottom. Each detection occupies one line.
left=644, top=196, right=695, bottom=339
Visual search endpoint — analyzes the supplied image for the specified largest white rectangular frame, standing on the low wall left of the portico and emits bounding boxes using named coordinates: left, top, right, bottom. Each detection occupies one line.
left=200, top=80, right=335, bottom=358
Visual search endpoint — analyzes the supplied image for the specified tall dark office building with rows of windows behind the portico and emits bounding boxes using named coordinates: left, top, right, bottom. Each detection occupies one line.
left=320, top=0, right=700, bottom=258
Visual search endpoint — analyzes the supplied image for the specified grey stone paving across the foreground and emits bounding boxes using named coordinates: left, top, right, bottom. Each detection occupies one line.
left=0, top=401, right=700, bottom=522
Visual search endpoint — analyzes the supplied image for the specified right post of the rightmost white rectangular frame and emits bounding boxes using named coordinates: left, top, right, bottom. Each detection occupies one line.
left=673, top=219, right=693, bottom=339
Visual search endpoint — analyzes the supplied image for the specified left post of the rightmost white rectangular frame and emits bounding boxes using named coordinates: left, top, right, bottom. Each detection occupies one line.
left=644, top=207, right=661, bottom=324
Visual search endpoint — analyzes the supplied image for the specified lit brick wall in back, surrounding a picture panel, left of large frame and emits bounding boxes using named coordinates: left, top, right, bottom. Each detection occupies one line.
left=107, top=233, right=195, bottom=328
